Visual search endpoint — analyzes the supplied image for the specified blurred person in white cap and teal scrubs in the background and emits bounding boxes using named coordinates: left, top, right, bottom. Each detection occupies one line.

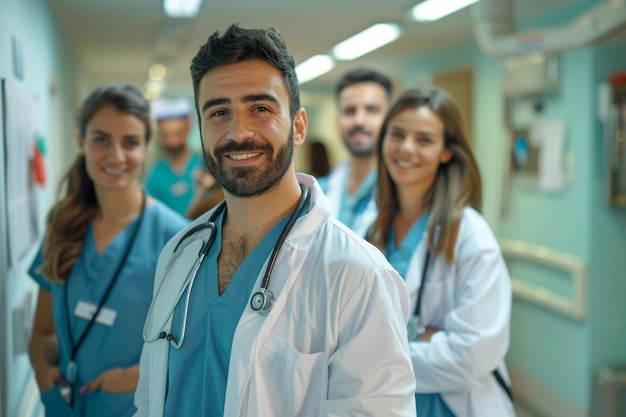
left=146, top=98, right=208, bottom=215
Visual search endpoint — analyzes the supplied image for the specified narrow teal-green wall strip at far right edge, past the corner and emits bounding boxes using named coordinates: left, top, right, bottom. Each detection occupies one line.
left=589, top=42, right=626, bottom=371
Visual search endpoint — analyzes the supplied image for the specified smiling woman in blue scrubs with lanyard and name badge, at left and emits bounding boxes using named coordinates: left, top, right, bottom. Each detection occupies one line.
left=29, top=84, right=187, bottom=417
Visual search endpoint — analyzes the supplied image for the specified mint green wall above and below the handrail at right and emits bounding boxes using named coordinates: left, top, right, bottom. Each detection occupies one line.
left=499, top=49, right=596, bottom=410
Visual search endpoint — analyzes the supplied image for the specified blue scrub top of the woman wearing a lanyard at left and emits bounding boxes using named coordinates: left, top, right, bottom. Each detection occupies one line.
left=29, top=201, right=189, bottom=417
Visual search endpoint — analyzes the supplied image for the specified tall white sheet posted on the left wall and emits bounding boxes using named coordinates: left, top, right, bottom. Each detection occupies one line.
left=2, top=80, right=39, bottom=267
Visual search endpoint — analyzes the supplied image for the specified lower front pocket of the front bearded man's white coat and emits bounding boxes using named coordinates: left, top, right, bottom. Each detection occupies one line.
left=251, top=334, right=328, bottom=417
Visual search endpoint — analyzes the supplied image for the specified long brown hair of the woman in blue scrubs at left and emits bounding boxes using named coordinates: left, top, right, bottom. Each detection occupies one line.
left=39, top=84, right=152, bottom=283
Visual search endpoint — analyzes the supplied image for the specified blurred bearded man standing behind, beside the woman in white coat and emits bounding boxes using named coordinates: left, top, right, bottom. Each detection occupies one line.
left=319, top=68, right=392, bottom=236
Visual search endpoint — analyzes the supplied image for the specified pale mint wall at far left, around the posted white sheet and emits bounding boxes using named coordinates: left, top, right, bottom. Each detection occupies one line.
left=0, top=0, right=80, bottom=417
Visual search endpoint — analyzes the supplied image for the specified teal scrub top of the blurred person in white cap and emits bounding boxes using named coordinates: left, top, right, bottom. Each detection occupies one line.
left=146, top=154, right=205, bottom=216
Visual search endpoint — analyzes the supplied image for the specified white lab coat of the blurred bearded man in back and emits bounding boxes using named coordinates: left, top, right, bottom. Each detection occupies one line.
left=326, top=161, right=378, bottom=237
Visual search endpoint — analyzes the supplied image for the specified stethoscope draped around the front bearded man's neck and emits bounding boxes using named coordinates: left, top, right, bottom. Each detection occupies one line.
left=142, top=184, right=309, bottom=349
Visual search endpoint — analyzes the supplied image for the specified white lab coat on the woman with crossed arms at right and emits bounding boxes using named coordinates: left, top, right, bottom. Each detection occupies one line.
left=406, top=208, right=515, bottom=417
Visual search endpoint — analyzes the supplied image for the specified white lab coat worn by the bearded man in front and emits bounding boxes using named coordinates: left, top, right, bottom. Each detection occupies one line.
left=135, top=175, right=416, bottom=417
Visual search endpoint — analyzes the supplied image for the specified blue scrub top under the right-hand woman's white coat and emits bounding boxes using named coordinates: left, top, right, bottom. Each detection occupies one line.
left=385, top=213, right=454, bottom=417
